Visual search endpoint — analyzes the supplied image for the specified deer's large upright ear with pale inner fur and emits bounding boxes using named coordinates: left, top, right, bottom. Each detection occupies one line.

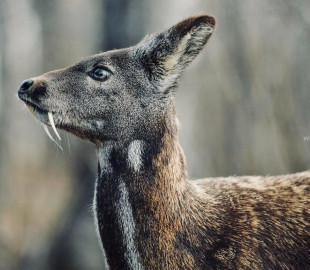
left=135, top=15, right=215, bottom=90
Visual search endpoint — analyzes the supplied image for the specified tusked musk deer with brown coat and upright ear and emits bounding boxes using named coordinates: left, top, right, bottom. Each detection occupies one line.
left=18, top=15, right=310, bottom=269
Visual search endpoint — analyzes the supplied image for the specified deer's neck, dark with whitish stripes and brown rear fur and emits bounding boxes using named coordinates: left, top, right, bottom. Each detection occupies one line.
left=94, top=110, right=188, bottom=269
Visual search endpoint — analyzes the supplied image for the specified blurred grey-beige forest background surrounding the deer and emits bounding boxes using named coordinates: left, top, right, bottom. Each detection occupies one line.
left=0, top=0, right=310, bottom=270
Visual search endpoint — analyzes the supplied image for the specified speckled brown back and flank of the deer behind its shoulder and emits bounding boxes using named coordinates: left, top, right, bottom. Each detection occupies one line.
left=193, top=171, right=310, bottom=269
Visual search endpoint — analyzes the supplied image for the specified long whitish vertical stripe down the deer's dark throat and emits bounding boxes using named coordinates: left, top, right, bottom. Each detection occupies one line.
left=117, top=180, right=144, bottom=270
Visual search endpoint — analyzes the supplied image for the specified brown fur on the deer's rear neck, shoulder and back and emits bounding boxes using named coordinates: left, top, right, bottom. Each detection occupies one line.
left=115, top=106, right=310, bottom=269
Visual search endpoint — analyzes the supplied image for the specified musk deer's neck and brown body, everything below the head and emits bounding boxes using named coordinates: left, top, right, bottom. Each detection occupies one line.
left=96, top=107, right=310, bottom=269
